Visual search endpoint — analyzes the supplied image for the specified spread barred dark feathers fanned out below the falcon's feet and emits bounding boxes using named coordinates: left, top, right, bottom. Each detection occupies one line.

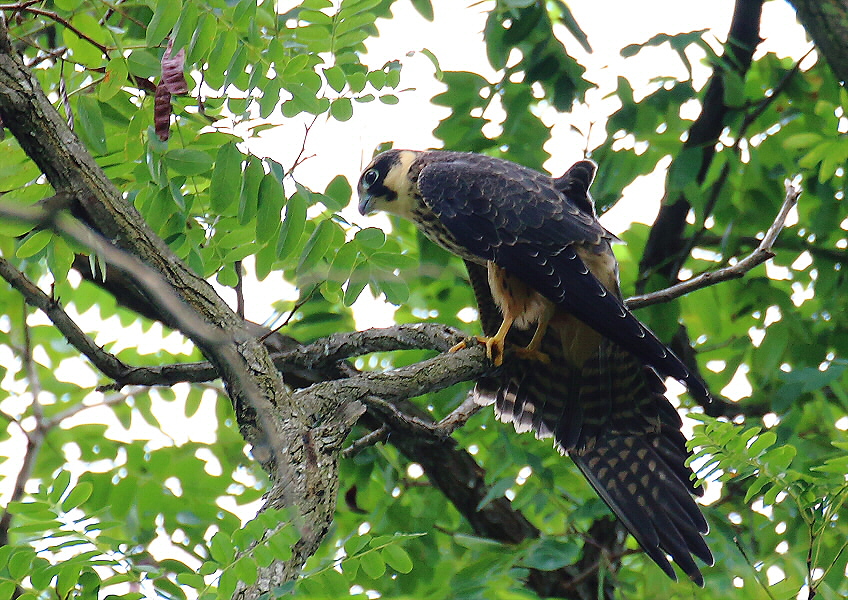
left=469, top=264, right=713, bottom=585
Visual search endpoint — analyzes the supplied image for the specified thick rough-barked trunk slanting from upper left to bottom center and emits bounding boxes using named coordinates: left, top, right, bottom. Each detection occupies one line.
left=0, top=19, right=362, bottom=598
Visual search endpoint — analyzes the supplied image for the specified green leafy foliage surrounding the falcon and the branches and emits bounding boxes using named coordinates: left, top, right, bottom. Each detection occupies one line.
left=0, top=0, right=848, bottom=600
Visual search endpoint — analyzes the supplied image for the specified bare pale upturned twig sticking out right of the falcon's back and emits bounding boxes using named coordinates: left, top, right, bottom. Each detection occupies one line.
left=625, top=183, right=801, bottom=309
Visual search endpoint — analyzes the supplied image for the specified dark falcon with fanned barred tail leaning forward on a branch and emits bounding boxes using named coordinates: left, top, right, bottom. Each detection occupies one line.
left=358, top=150, right=713, bottom=585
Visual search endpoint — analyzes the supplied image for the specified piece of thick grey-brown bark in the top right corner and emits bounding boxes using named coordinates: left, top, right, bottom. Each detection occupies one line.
left=789, top=0, right=848, bottom=86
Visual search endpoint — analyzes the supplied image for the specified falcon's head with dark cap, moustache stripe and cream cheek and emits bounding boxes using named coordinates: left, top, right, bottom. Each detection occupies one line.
left=356, top=150, right=419, bottom=217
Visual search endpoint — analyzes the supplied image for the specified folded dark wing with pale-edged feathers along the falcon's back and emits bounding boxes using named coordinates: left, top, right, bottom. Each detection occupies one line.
left=418, top=152, right=709, bottom=400
